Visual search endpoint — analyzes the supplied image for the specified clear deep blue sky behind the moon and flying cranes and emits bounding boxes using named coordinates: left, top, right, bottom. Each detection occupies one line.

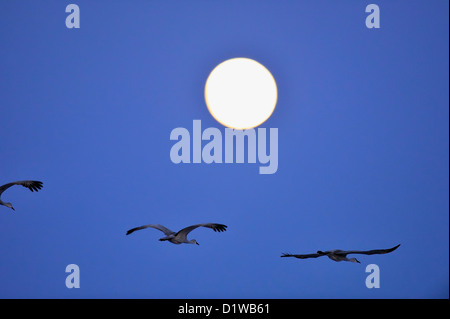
left=0, top=0, right=449, bottom=298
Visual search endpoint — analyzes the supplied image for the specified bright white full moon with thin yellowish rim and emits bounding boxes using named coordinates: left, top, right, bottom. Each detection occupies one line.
left=205, top=58, right=278, bottom=130
